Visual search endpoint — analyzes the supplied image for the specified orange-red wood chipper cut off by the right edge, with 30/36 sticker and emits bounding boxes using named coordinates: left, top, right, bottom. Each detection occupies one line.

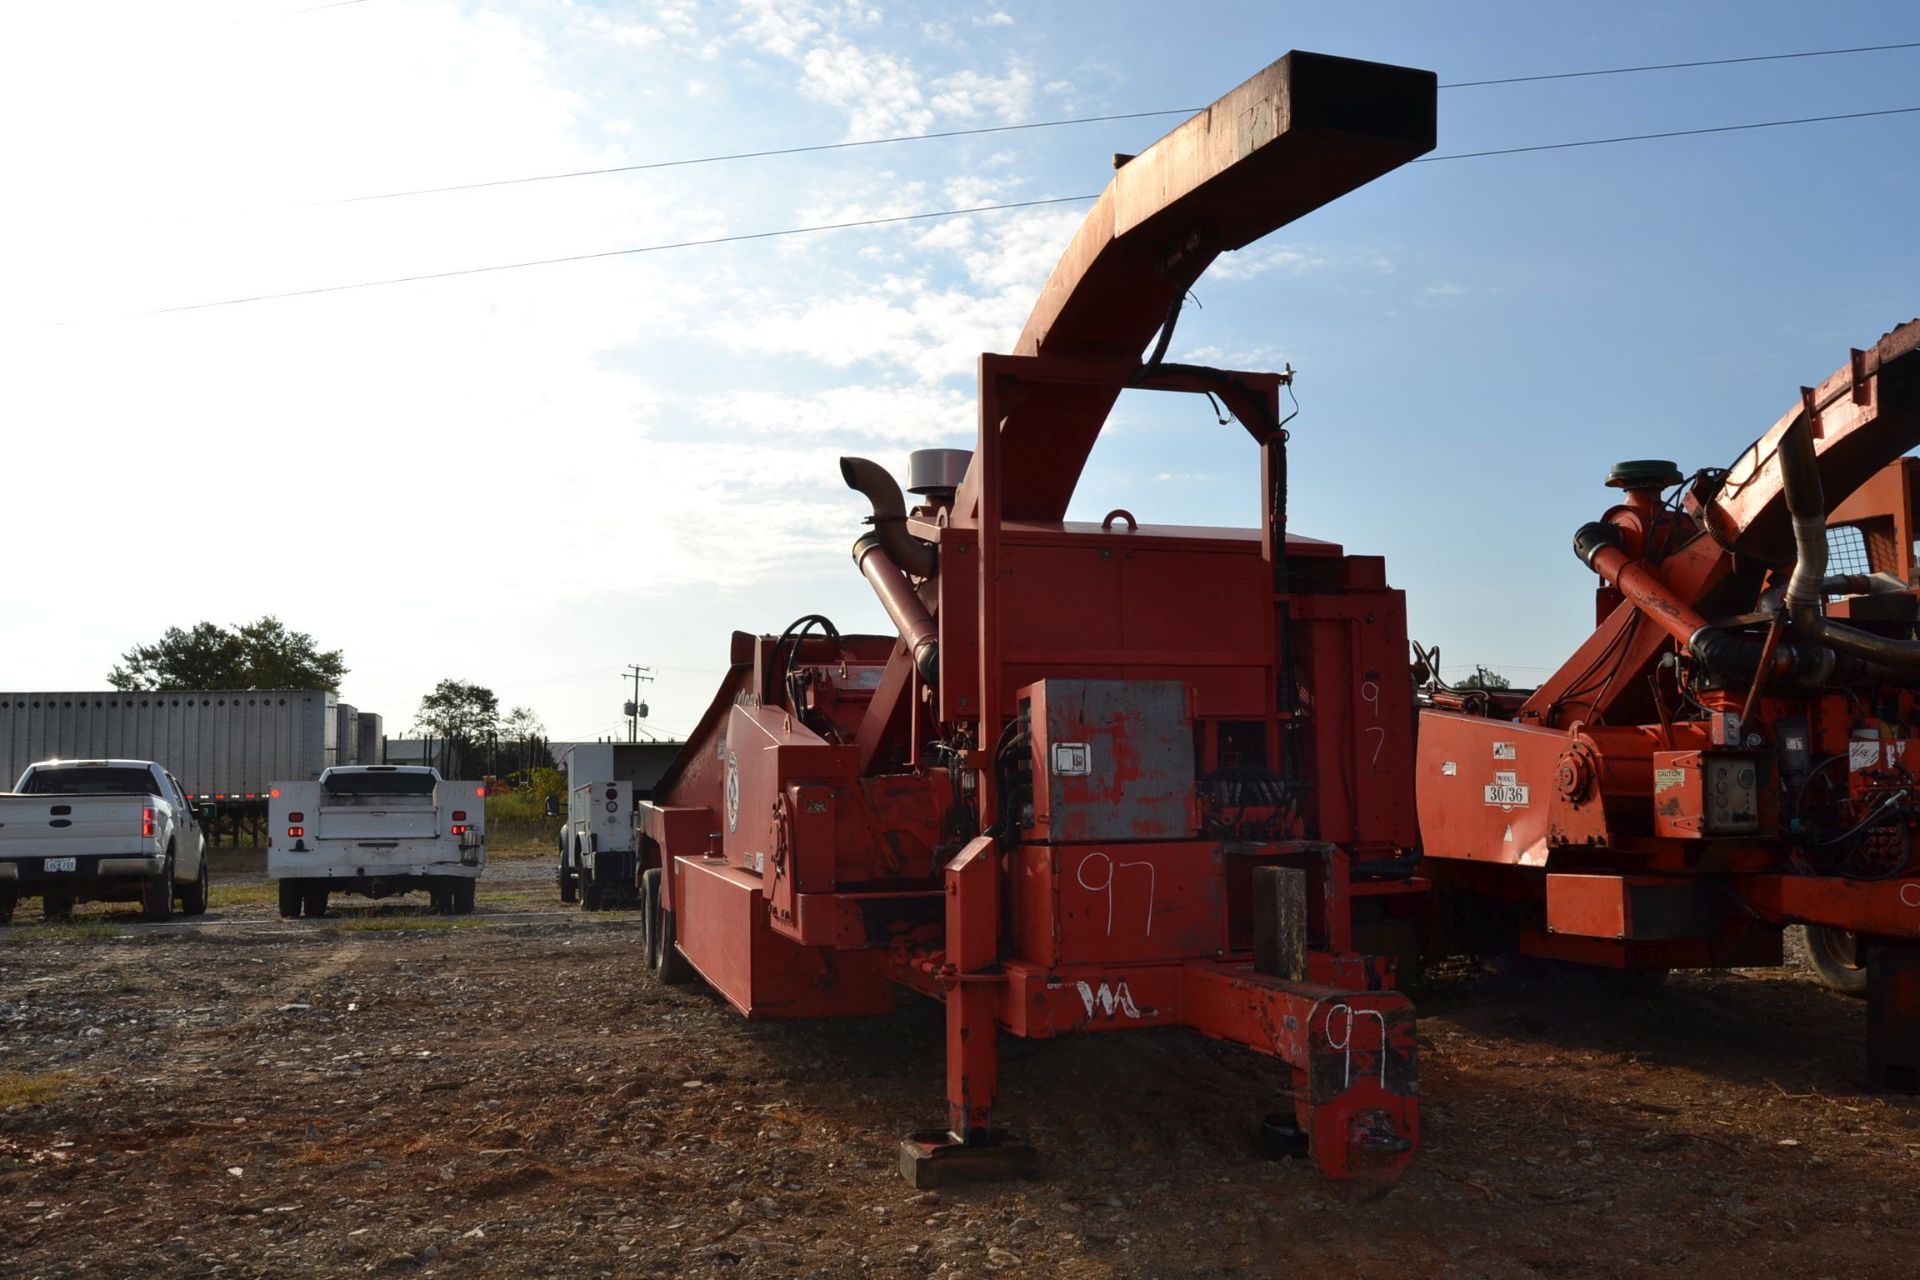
left=1419, top=320, right=1920, bottom=1092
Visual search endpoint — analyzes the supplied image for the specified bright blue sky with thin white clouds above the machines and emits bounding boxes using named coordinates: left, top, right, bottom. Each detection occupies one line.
left=0, top=0, right=1920, bottom=737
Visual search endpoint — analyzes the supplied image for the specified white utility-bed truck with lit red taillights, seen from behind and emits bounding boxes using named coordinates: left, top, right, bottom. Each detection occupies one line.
left=267, top=764, right=486, bottom=917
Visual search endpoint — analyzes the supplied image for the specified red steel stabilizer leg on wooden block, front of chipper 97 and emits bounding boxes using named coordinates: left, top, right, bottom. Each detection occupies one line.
left=900, top=837, right=1033, bottom=1186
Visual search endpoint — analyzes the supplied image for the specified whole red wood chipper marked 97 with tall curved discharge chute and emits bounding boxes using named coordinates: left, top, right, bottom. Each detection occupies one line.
left=636, top=54, right=1436, bottom=1186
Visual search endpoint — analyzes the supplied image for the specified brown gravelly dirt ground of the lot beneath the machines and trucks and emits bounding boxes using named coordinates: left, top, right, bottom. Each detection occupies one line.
left=0, top=856, right=1920, bottom=1280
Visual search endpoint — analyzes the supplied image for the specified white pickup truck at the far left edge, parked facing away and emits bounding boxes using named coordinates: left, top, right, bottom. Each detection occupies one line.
left=0, top=760, right=213, bottom=925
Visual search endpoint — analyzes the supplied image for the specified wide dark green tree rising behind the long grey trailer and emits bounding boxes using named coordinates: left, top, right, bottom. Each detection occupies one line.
left=108, top=614, right=348, bottom=691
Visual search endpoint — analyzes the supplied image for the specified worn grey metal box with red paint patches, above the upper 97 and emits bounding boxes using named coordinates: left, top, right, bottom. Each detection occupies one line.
left=1020, top=679, right=1194, bottom=844
